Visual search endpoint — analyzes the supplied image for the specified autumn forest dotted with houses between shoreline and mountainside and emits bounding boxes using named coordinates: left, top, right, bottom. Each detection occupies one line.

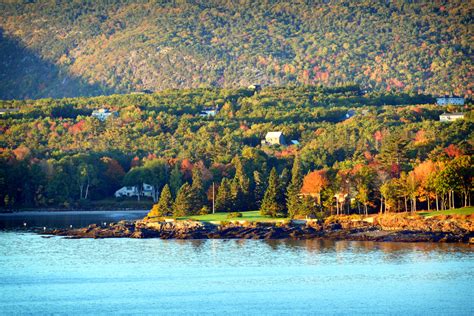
left=0, top=85, right=474, bottom=216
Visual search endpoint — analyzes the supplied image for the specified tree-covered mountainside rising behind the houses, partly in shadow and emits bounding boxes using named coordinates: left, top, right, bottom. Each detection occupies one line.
left=0, top=0, right=474, bottom=99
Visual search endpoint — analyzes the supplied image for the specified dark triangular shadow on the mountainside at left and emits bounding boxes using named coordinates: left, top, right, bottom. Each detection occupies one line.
left=0, top=28, right=115, bottom=100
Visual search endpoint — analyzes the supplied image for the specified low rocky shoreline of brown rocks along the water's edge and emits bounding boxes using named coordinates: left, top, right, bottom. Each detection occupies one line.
left=41, top=216, right=474, bottom=243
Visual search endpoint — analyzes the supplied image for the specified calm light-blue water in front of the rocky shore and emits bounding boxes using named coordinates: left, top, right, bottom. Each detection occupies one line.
left=0, top=214, right=474, bottom=315
